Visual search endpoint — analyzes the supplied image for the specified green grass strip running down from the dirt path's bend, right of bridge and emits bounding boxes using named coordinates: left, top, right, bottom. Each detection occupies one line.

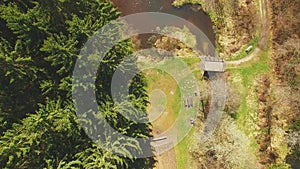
left=228, top=50, right=270, bottom=152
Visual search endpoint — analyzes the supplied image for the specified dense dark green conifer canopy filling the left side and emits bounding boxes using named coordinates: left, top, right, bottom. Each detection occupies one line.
left=0, top=0, right=154, bottom=168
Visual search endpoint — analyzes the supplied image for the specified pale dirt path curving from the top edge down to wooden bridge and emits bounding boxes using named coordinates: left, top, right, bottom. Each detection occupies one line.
left=226, top=0, right=269, bottom=66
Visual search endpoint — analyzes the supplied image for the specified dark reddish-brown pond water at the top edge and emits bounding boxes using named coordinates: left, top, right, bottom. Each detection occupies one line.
left=112, top=0, right=215, bottom=53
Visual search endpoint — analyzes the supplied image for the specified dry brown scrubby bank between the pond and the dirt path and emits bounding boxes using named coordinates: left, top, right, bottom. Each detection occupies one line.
left=173, top=0, right=260, bottom=58
